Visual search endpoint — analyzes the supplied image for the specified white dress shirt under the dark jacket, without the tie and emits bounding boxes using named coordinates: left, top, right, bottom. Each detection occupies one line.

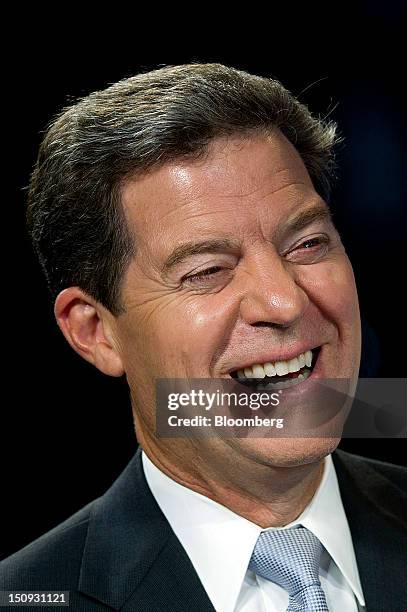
left=142, top=452, right=365, bottom=612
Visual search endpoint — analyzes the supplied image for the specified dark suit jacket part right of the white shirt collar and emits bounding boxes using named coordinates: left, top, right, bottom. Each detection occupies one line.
left=333, top=451, right=407, bottom=612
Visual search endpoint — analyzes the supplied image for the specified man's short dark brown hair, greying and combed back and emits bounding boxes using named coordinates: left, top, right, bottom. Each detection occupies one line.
left=26, top=63, right=339, bottom=316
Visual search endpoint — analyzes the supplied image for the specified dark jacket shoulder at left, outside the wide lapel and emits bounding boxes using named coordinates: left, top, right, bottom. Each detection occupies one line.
left=0, top=500, right=97, bottom=591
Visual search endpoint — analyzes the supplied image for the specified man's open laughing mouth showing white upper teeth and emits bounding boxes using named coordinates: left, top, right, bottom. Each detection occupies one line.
left=230, top=346, right=321, bottom=391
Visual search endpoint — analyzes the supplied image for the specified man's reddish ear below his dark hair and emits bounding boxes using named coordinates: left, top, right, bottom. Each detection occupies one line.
left=54, top=287, right=124, bottom=376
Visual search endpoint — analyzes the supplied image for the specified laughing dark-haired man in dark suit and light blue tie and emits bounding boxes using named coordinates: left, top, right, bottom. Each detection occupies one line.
left=1, top=64, right=407, bottom=612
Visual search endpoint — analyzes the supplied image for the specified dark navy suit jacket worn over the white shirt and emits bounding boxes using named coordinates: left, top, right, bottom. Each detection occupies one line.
left=0, top=450, right=407, bottom=612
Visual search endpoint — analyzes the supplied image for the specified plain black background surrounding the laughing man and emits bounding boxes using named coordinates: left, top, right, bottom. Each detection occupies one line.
left=0, top=2, right=407, bottom=556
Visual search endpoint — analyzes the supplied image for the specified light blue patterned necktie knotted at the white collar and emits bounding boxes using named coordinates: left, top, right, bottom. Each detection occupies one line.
left=249, top=527, right=329, bottom=612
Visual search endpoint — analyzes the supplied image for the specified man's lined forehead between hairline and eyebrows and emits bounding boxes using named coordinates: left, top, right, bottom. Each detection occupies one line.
left=122, top=130, right=315, bottom=244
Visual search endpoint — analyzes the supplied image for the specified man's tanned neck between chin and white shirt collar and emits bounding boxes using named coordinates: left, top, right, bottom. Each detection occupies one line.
left=140, top=430, right=324, bottom=528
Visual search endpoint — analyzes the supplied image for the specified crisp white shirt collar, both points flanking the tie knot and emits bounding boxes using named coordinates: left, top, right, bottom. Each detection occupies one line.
left=142, top=452, right=365, bottom=612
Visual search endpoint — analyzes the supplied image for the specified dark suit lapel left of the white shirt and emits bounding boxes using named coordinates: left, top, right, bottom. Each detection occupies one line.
left=78, top=449, right=214, bottom=612
